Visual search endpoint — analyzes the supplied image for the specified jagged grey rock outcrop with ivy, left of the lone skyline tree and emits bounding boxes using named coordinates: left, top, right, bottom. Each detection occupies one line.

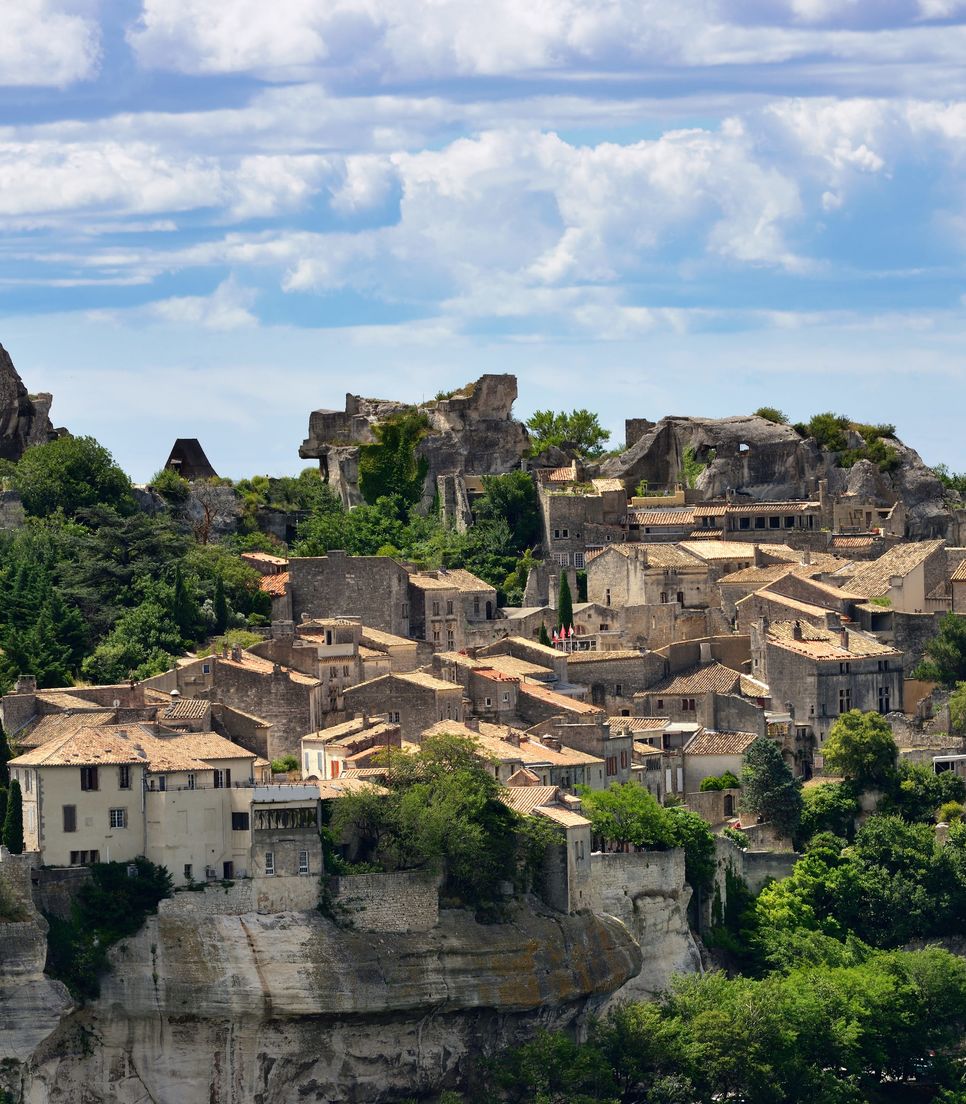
left=298, top=375, right=530, bottom=506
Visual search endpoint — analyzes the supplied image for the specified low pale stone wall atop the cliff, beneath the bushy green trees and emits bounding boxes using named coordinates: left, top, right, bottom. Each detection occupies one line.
left=332, top=870, right=442, bottom=932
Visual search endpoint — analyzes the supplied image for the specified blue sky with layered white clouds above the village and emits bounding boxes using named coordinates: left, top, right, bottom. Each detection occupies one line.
left=0, top=0, right=966, bottom=480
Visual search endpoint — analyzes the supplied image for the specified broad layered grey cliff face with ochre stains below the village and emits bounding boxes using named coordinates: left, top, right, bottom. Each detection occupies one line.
left=24, top=910, right=641, bottom=1104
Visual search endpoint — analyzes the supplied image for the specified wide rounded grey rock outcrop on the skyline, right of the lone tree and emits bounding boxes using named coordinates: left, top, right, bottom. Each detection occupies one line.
left=601, top=415, right=953, bottom=539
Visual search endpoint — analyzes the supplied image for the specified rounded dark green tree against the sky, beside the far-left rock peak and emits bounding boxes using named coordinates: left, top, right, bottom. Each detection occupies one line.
left=15, top=437, right=134, bottom=517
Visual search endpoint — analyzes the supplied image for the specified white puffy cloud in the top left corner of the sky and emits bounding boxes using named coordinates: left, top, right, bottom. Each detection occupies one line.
left=0, top=0, right=100, bottom=87
